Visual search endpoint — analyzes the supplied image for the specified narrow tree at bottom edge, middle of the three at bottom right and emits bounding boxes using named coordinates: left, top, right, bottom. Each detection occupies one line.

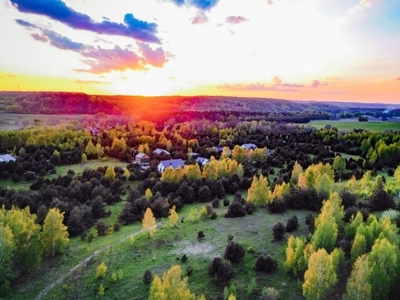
left=343, top=255, right=372, bottom=300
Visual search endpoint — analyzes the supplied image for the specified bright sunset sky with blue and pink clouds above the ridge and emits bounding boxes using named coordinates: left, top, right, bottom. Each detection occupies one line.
left=0, top=0, right=400, bottom=104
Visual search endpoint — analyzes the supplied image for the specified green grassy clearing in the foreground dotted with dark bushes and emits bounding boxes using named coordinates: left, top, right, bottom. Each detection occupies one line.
left=9, top=202, right=308, bottom=299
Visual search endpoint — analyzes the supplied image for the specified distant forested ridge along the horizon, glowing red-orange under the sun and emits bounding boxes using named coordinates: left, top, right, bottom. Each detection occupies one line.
left=0, top=92, right=400, bottom=121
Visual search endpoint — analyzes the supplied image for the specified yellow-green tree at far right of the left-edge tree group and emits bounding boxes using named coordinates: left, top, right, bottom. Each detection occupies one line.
left=42, top=208, right=69, bottom=256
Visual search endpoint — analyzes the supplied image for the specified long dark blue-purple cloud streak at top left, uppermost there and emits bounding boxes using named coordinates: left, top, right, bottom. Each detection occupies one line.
left=10, top=0, right=160, bottom=43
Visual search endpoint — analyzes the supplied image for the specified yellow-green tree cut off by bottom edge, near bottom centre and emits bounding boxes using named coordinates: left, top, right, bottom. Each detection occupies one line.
left=149, top=265, right=204, bottom=300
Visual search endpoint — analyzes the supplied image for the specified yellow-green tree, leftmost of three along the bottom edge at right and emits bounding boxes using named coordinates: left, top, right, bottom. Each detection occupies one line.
left=302, top=248, right=337, bottom=300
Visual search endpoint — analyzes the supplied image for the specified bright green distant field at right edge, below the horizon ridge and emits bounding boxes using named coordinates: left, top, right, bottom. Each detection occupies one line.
left=308, top=119, right=400, bottom=132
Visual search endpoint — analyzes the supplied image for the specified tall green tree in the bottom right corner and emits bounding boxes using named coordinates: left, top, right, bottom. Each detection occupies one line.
left=368, top=238, right=399, bottom=299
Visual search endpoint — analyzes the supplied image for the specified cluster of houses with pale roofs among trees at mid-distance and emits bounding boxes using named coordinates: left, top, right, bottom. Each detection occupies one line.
left=134, top=143, right=264, bottom=173
